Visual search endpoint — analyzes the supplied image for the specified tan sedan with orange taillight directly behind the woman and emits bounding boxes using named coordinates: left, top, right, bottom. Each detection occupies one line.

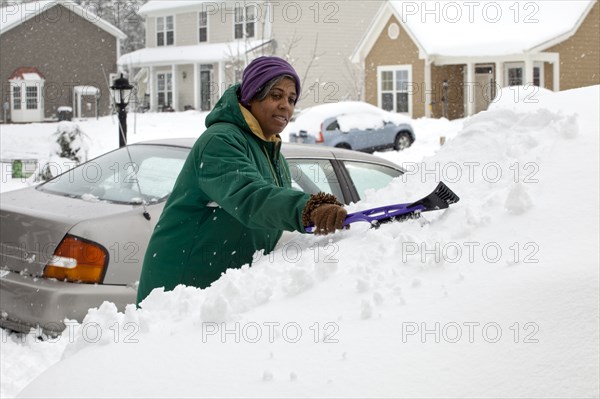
left=0, top=139, right=403, bottom=332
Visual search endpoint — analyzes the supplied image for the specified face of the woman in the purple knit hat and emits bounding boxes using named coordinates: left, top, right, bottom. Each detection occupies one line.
left=250, top=78, right=296, bottom=139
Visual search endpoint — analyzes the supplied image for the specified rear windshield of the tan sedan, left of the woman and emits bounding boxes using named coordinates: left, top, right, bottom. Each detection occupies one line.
left=38, top=145, right=189, bottom=204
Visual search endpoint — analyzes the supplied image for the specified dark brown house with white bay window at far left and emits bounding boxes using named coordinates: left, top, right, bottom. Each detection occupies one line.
left=0, top=0, right=126, bottom=122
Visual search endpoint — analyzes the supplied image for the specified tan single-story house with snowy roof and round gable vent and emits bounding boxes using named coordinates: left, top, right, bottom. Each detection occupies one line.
left=352, top=1, right=600, bottom=119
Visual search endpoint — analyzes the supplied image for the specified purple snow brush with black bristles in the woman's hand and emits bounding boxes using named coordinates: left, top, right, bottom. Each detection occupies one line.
left=306, top=182, right=460, bottom=233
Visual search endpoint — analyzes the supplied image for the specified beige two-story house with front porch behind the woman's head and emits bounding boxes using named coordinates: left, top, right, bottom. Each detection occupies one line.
left=118, top=0, right=383, bottom=111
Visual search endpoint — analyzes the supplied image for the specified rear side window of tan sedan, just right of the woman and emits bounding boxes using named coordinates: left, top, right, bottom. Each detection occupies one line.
left=288, top=159, right=344, bottom=202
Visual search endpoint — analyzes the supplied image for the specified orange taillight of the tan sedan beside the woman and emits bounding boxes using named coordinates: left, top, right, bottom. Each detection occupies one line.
left=44, top=235, right=108, bottom=283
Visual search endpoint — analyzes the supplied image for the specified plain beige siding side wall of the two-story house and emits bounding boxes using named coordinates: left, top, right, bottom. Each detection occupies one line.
left=272, top=0, right=384, bottom=108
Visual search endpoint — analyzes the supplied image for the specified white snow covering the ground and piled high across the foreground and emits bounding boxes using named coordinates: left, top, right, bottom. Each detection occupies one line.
left=0, top=86, right=600, bottom=397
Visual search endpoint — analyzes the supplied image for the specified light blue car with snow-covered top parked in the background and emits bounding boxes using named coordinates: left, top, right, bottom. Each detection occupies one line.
left=289, top=101, right=415, bottom=152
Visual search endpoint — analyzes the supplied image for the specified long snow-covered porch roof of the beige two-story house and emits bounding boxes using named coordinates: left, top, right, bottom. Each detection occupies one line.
left=117, top=40, right=269, bottom=67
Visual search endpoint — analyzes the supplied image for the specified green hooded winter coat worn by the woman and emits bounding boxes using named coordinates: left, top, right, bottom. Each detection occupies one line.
left=137, top=85, right=309, bottom=303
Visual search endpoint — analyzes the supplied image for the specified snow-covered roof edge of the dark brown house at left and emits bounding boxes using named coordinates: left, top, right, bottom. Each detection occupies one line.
left=0, top=0, right=127, bottom=39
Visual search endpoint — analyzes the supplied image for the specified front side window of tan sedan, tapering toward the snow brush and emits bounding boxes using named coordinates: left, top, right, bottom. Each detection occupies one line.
left=343, top=161, right=402, bottom=199
